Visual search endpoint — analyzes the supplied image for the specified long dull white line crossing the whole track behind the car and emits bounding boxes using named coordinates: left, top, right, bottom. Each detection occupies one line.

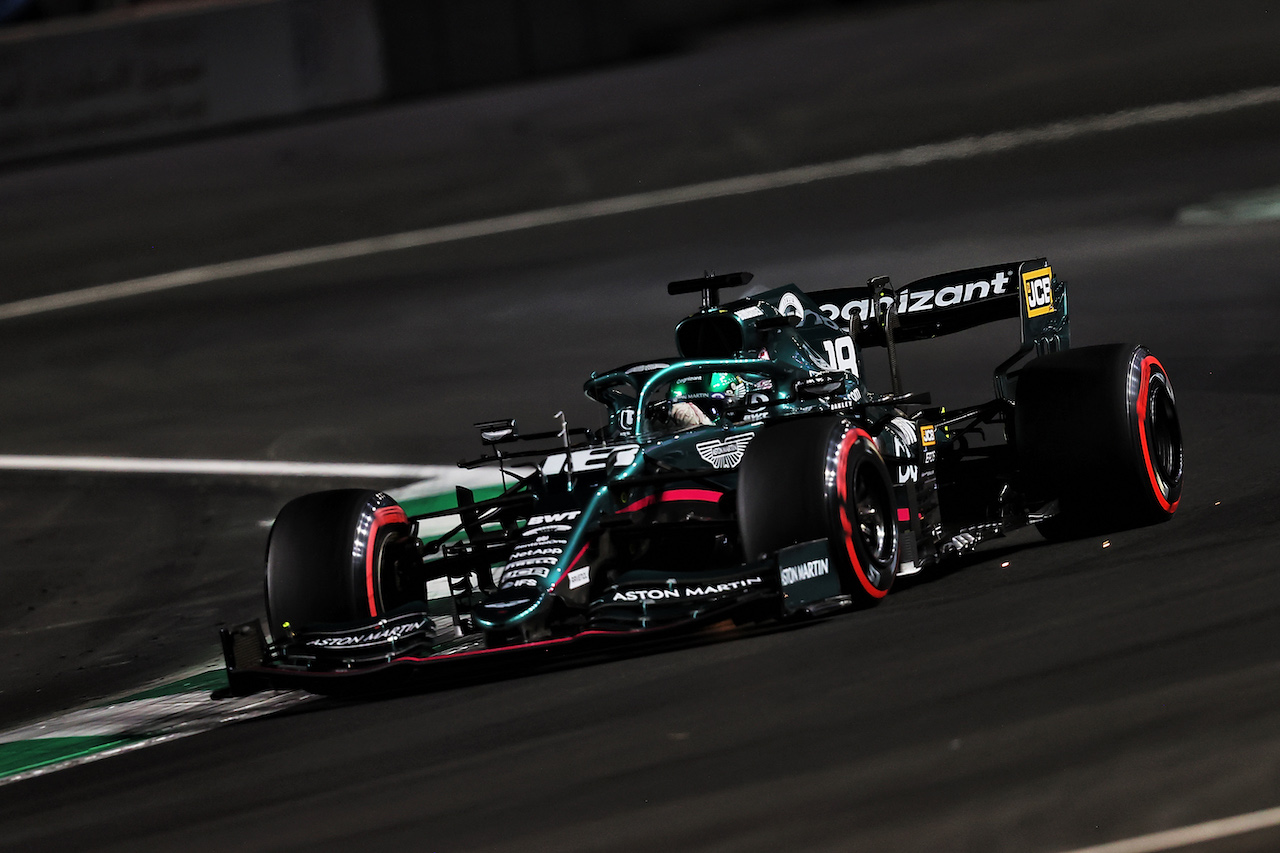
left=0, top=86, right=1280, bottom=320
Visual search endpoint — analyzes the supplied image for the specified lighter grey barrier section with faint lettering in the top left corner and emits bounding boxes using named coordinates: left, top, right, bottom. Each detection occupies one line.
left=0, top=0, right=385, bottom=161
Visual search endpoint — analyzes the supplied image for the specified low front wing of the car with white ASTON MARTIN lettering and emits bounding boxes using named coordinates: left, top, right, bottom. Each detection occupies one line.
left=221, top=540, right=850, bottom=695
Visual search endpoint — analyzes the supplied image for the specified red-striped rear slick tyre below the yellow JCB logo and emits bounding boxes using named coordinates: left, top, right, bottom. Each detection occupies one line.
left=1014, top=343, right=1183, bottom=539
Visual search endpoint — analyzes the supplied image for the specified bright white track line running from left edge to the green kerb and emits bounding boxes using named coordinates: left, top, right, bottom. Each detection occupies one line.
left=0, top=456, right=455, bottom=482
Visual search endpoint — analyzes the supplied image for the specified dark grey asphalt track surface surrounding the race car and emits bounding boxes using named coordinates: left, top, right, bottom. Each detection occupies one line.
left=0, top=3, right=1280, bottom=852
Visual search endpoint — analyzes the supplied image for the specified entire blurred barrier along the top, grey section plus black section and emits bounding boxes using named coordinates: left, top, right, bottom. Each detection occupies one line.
left=0, top=0, right=839, bottom=163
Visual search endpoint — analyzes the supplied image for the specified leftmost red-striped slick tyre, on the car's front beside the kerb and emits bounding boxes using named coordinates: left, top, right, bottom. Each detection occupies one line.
left=266, top=489, right=412, bottom=637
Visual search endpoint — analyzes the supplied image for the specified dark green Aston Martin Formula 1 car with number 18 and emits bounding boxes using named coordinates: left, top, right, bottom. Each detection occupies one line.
left=223, top=259, right=1183, bottom=692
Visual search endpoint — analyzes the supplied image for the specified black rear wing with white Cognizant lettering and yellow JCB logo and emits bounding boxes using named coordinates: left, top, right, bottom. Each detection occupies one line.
left=809, top=257, right=1071, bottom=400
